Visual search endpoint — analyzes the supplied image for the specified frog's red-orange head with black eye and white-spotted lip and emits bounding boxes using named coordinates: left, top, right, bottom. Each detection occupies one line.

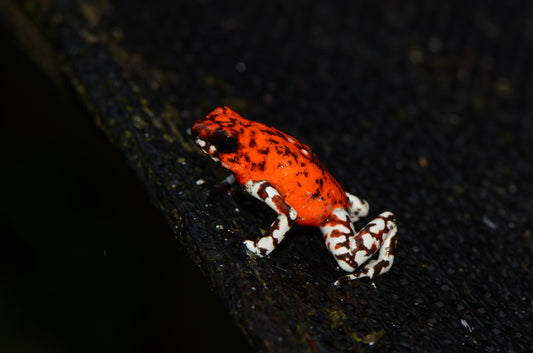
left=191, top=107, right=239, bottom=161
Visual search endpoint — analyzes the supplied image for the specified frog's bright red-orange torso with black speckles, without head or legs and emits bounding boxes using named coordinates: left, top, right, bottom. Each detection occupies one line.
left=223, top=116, right=348, bottom=226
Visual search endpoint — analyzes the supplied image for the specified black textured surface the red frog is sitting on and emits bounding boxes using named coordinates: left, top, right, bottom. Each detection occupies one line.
left=5, top=1, right=533, bottom=352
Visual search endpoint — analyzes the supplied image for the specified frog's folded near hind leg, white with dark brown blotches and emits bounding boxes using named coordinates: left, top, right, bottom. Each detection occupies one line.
left=320, top=208, right=397, bottom=279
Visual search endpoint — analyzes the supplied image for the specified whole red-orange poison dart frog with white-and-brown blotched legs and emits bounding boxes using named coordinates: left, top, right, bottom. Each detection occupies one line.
left=191, top=107, right=397, bottom=279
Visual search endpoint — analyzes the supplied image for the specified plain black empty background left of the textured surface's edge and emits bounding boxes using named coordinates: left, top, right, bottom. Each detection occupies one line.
left=0, top=21, right=250, bottom=353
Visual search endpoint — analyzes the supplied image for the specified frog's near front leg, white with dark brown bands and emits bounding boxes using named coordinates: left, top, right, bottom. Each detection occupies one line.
left=244, top=180, right=297, bottom=257
